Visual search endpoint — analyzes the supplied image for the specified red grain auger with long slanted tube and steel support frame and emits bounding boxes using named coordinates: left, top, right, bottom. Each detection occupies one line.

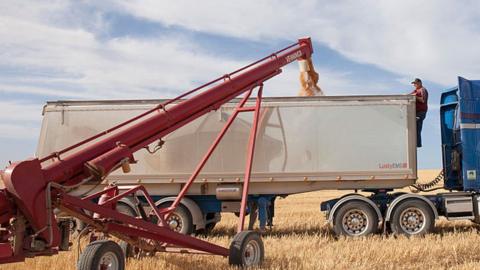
left=0, top=38, right=313, bottom=264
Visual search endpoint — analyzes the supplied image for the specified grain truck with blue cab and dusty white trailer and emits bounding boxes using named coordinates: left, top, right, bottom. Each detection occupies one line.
left=37, top=78, right=480, bottom=236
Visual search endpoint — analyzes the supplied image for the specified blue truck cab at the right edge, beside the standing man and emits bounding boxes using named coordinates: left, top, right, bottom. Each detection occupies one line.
left=440, top=77, right=480, bottom=192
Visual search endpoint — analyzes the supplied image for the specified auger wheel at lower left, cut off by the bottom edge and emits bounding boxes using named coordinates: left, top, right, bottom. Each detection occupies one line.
left=77, top=240, right=125, bottom=270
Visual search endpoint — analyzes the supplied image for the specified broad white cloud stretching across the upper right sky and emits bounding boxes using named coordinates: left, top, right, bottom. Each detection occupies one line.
left=107, top=0, right=480, bottom=85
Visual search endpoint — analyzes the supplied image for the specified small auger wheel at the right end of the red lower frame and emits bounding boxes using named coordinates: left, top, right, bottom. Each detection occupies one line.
left=228, top=231, right=265, bottom=267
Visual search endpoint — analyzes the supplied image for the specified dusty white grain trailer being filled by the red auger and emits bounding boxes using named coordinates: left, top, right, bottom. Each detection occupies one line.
left=37, top=95, right=417, bottom=233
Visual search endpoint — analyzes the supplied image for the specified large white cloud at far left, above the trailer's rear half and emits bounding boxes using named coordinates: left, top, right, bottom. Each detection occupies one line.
left=0, top=3, right=253, bottom=99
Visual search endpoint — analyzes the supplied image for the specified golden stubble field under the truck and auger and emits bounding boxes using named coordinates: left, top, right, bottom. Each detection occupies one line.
left=5, top=170, right=480, bottom=270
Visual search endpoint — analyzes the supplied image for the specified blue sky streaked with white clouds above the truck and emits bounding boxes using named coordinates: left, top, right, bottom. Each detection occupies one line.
left=0, top=0, right=480, bottom=169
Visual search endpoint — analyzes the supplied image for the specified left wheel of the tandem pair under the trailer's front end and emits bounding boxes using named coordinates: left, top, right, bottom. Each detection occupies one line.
left=333, top=200, right=379, bottom=237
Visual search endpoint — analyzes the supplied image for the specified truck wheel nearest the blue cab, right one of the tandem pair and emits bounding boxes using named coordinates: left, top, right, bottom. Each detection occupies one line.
left=390, top=199, right=435, bottom=236
